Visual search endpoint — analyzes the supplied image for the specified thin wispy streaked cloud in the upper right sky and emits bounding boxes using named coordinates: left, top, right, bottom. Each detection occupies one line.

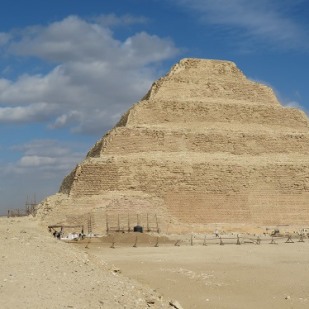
left=172, top=0, right=309, bottom=50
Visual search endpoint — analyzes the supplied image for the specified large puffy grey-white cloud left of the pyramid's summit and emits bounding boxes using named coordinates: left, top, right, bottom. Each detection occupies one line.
left=0, top=15, right=178, bottom=134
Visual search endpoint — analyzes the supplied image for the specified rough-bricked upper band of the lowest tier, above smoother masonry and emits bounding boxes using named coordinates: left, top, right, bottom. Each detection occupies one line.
left=61, top=152, right=309, bottom=195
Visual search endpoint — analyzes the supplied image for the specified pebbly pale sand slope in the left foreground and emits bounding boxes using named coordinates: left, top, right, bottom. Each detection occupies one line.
left=0, top=218, right=170, bottom=309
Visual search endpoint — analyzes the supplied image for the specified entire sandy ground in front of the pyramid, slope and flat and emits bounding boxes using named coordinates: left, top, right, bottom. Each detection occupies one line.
left=0, top=218, right=309, bottom=309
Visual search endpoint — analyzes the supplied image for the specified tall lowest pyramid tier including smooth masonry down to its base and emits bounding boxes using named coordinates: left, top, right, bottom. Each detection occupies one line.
left=62, top=153, right=309, bottom=224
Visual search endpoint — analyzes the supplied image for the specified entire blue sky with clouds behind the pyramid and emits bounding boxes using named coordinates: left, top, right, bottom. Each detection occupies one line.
left=0, top=0, right=309, bottom=213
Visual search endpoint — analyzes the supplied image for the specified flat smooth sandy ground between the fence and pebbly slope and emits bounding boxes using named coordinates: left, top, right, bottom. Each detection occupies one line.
left=86, top=241, right=309, bottom=309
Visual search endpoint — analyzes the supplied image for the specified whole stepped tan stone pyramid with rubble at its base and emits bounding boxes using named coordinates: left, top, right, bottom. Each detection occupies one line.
left=39, top=59, right=309, bottom=231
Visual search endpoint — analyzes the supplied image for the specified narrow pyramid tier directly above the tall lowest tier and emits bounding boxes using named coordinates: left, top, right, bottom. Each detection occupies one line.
left=88, top=125, right=309, bottom=157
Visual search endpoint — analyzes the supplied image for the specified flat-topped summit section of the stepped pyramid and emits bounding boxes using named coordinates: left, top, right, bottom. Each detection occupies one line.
left=145, top=59, right=279, bottom=105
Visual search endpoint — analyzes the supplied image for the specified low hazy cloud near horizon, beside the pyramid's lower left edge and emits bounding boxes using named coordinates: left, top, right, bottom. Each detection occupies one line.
left=0, top=139, right=88, bottom=208
